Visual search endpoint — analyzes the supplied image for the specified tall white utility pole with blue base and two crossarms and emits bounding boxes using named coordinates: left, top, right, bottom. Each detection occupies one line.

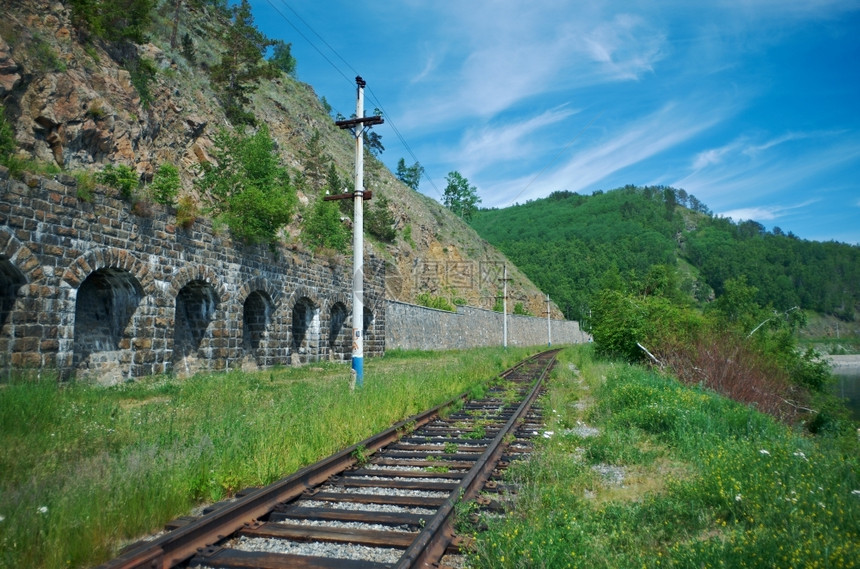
left=330, top=76, right=383, bottom=387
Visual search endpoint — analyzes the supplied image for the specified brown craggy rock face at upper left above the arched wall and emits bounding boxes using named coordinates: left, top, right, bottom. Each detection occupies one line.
left=0, top=0, right=223, bottom=183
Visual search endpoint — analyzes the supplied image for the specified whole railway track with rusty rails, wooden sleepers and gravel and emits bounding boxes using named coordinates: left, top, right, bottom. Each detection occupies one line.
left=99, top=350, right=558, bottom=569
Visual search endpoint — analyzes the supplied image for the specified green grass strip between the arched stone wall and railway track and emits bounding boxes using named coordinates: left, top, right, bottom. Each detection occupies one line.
left=0, top=349, right=527, bottom=569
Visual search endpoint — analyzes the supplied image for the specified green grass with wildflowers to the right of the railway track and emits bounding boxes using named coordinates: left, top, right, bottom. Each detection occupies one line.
left=469, top=347, right=860, bottom=569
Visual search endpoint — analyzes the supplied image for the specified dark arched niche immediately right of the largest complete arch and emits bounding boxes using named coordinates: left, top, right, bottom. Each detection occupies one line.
left=173, top=279, right=218, bottom=375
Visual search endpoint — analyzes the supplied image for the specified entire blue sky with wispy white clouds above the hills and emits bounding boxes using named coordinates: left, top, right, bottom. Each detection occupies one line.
left=245, top=0, right=860, bottom=244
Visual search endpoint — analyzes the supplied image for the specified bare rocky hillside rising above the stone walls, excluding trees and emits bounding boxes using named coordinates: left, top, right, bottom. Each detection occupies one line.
left=0, top=0, right=561, bottom=318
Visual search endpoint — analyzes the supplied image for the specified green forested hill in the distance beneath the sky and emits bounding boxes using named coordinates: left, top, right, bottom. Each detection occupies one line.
left=471, top=186, right=860, bottom=321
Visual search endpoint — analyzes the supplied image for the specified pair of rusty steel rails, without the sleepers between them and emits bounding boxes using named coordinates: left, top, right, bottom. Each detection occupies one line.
left=98, top=350, right=558, bottom=569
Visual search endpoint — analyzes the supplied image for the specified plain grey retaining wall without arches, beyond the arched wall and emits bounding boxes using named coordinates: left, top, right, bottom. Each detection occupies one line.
left=385, top=300, right=590, bottom=350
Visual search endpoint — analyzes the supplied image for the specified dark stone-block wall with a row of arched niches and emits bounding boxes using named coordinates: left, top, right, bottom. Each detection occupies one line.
left=0, top=167, right=385, bottom=384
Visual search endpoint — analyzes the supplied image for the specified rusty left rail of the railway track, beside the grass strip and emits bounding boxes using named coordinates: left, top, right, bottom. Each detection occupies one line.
left=96, top=352, right=546, bottom=569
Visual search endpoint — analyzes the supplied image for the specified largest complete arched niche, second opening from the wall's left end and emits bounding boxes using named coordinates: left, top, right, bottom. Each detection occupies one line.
left=73, top=267, right=144, bottom=383
